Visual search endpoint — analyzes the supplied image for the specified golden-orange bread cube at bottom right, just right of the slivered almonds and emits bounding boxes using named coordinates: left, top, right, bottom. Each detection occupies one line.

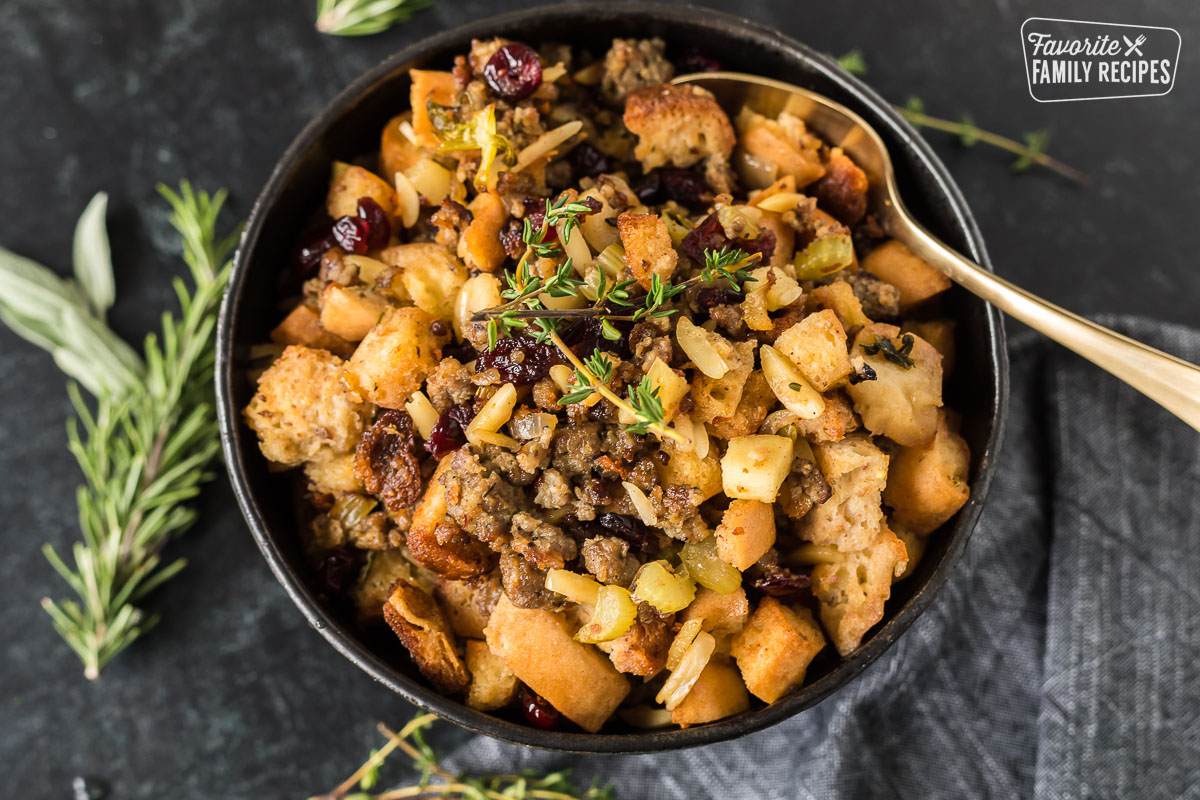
left=731, top=597, right=826, bottom=703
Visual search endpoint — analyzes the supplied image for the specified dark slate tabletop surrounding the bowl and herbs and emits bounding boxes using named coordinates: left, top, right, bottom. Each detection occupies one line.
left=0, top=0, right=1200, bottom=800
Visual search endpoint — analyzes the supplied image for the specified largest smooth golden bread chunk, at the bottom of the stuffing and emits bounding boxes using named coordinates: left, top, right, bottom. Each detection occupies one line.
left=484, top=595, right=629, bottom=733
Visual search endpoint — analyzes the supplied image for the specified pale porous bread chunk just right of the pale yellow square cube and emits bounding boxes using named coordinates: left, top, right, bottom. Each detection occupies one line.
left=800, top=435, right=888, bottom=552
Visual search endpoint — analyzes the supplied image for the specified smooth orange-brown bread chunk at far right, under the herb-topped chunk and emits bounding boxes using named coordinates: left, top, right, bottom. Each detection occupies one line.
left=883, top=411, right=971, bottom=535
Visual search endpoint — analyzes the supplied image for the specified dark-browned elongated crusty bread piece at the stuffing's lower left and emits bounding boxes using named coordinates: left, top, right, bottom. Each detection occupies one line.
left=383, top=579, right=470, bottom=694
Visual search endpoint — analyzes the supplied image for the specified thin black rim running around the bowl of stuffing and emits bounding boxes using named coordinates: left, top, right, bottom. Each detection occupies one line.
left=214, top=1, right=1008, bottom=753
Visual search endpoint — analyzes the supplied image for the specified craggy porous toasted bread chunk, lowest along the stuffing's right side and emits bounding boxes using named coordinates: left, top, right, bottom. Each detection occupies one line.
left=812, top=525, right=908, bottom=655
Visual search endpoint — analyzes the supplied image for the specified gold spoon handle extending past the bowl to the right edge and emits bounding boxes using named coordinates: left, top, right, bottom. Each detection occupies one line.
left=887, top=213, right=1200, bottom=431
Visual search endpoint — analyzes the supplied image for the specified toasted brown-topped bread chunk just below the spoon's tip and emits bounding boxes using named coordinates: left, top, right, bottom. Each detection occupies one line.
left=625, top=84, right=734, bottom=172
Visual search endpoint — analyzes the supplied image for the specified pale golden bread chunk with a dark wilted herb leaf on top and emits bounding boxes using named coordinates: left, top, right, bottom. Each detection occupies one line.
left=846, top=323, right=942, bottom=447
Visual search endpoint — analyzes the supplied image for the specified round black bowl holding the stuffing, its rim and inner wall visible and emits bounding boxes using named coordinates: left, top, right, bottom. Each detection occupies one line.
left=216, top=2, right=1008, bottom=753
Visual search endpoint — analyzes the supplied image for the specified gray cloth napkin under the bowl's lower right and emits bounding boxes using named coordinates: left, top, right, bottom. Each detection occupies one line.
left=448, top=319, right=1200, bottom=800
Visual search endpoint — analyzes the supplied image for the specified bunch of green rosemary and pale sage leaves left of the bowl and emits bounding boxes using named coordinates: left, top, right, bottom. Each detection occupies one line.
left=0, top=182, right=235, bottom=679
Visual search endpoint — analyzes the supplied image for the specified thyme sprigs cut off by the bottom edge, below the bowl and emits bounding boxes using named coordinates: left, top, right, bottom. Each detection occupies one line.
left=310, top=714, right=616, bottom=800
